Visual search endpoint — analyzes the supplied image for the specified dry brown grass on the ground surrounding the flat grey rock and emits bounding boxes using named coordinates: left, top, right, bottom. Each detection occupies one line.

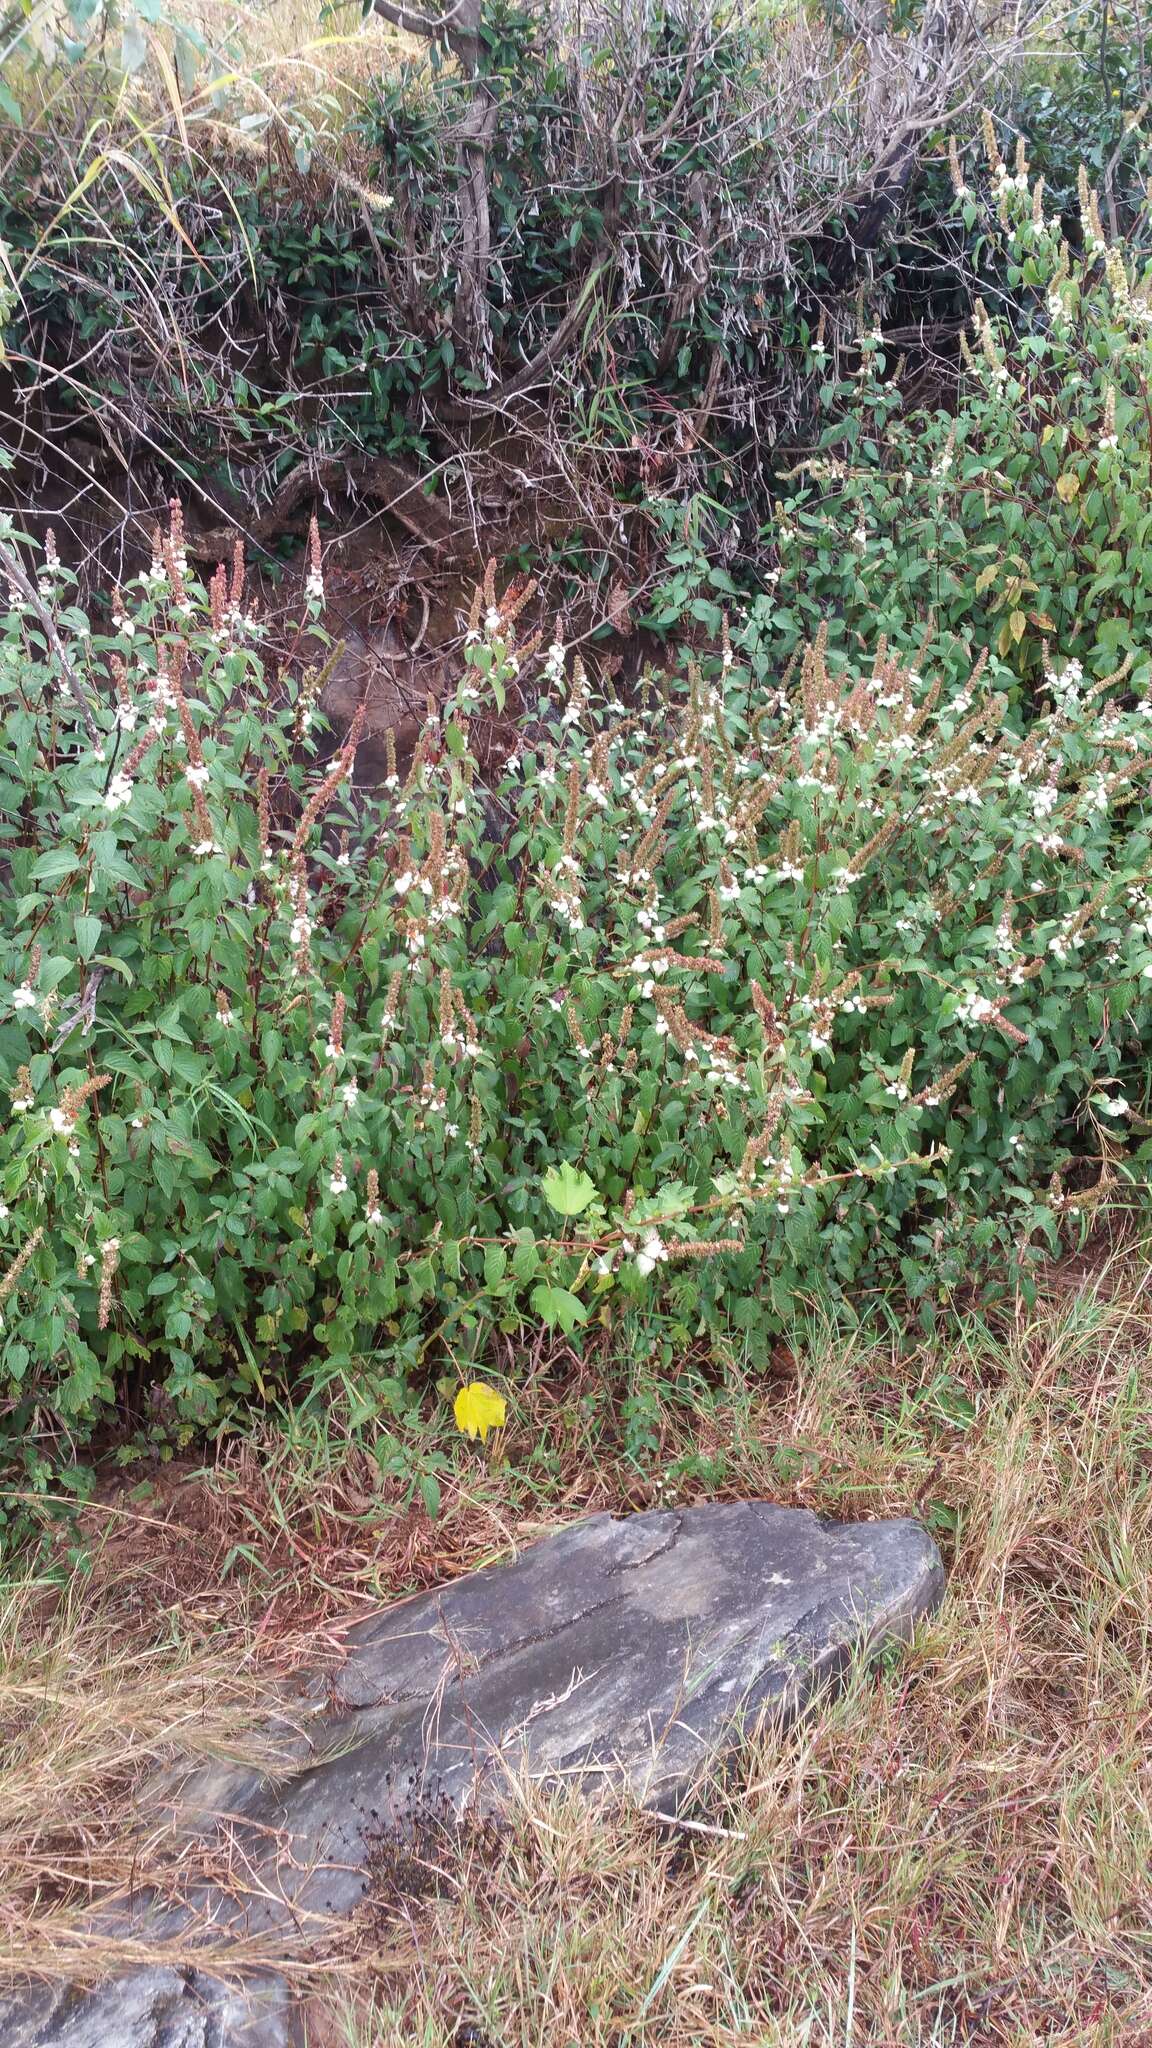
left=0, top=1264, right=1152, bottom=2048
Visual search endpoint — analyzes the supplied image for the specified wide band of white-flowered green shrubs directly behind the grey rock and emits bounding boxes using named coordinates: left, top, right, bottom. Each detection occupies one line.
left=0, top=491, right=1152, bottom=1458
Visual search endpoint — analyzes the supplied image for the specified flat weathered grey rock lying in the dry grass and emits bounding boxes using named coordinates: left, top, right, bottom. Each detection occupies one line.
left=0, top=1501, right=943, bottom=2048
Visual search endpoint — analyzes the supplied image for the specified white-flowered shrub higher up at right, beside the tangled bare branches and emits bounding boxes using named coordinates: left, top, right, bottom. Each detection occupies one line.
left=668, top=127, right=1152, bottom=702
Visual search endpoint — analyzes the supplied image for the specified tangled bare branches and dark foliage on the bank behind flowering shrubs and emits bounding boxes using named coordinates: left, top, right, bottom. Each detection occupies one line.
left=0, top=0, right=1027, bottom=618
